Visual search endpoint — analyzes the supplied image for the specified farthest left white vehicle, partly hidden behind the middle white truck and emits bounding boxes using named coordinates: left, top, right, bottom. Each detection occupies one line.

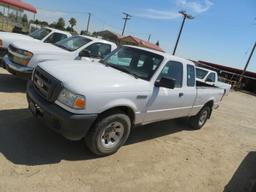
left=0, top=27, right=71, bottom=60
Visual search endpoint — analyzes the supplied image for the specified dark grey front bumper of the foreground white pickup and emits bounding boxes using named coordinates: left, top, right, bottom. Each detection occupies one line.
left=27, top=81, right=97, bottom=140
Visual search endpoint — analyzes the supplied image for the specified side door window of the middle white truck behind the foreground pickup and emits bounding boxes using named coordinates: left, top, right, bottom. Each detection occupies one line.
left=86, top=43, right=111, bottom=58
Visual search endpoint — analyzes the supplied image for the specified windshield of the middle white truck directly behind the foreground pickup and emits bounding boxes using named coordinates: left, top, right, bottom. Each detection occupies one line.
left=55, top=36, right=92, bottom=51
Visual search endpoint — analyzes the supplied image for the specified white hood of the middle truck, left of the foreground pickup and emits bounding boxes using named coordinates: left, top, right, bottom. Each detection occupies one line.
left=12, top=41, right=69, bottom=55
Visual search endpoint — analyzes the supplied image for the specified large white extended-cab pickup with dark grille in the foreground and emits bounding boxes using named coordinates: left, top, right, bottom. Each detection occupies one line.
left=27, top=46, right=224, bottom=156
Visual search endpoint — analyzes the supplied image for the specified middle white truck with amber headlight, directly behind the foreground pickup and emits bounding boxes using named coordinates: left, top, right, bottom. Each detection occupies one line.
left=3, top=35, right=117, bottom=78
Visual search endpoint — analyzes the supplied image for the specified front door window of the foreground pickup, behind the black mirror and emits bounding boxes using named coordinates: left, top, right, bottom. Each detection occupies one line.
left=158, top=61, right=183, bottom=88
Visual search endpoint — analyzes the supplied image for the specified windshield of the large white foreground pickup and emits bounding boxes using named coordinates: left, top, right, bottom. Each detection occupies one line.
left=102, top=47, right=163, bottom=81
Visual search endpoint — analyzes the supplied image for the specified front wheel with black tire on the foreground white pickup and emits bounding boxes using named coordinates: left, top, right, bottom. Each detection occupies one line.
left=85, top=111, right=131, bottom=156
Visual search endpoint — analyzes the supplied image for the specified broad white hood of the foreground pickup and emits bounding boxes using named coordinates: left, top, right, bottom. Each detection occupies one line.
left=39, top=60, right=150, bottom=95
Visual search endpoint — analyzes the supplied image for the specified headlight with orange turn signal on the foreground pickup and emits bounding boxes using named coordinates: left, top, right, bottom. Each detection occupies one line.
left=58, top=89, right=86, bottom=109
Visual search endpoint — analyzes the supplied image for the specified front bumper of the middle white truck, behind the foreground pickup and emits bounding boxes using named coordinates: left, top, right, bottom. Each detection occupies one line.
left=3, top=55, right=33, bottom=79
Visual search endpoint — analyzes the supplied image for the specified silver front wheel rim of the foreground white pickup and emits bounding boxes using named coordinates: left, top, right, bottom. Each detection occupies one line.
left=101, top=121, right=124, bottom=148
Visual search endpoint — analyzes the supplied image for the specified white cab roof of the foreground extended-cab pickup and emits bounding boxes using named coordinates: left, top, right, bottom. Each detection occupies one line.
left=124, top=45, right=195, bottom=65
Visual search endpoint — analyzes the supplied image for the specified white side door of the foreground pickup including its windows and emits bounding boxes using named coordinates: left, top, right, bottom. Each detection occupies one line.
left=144, top=61, right=196, bottom=122
